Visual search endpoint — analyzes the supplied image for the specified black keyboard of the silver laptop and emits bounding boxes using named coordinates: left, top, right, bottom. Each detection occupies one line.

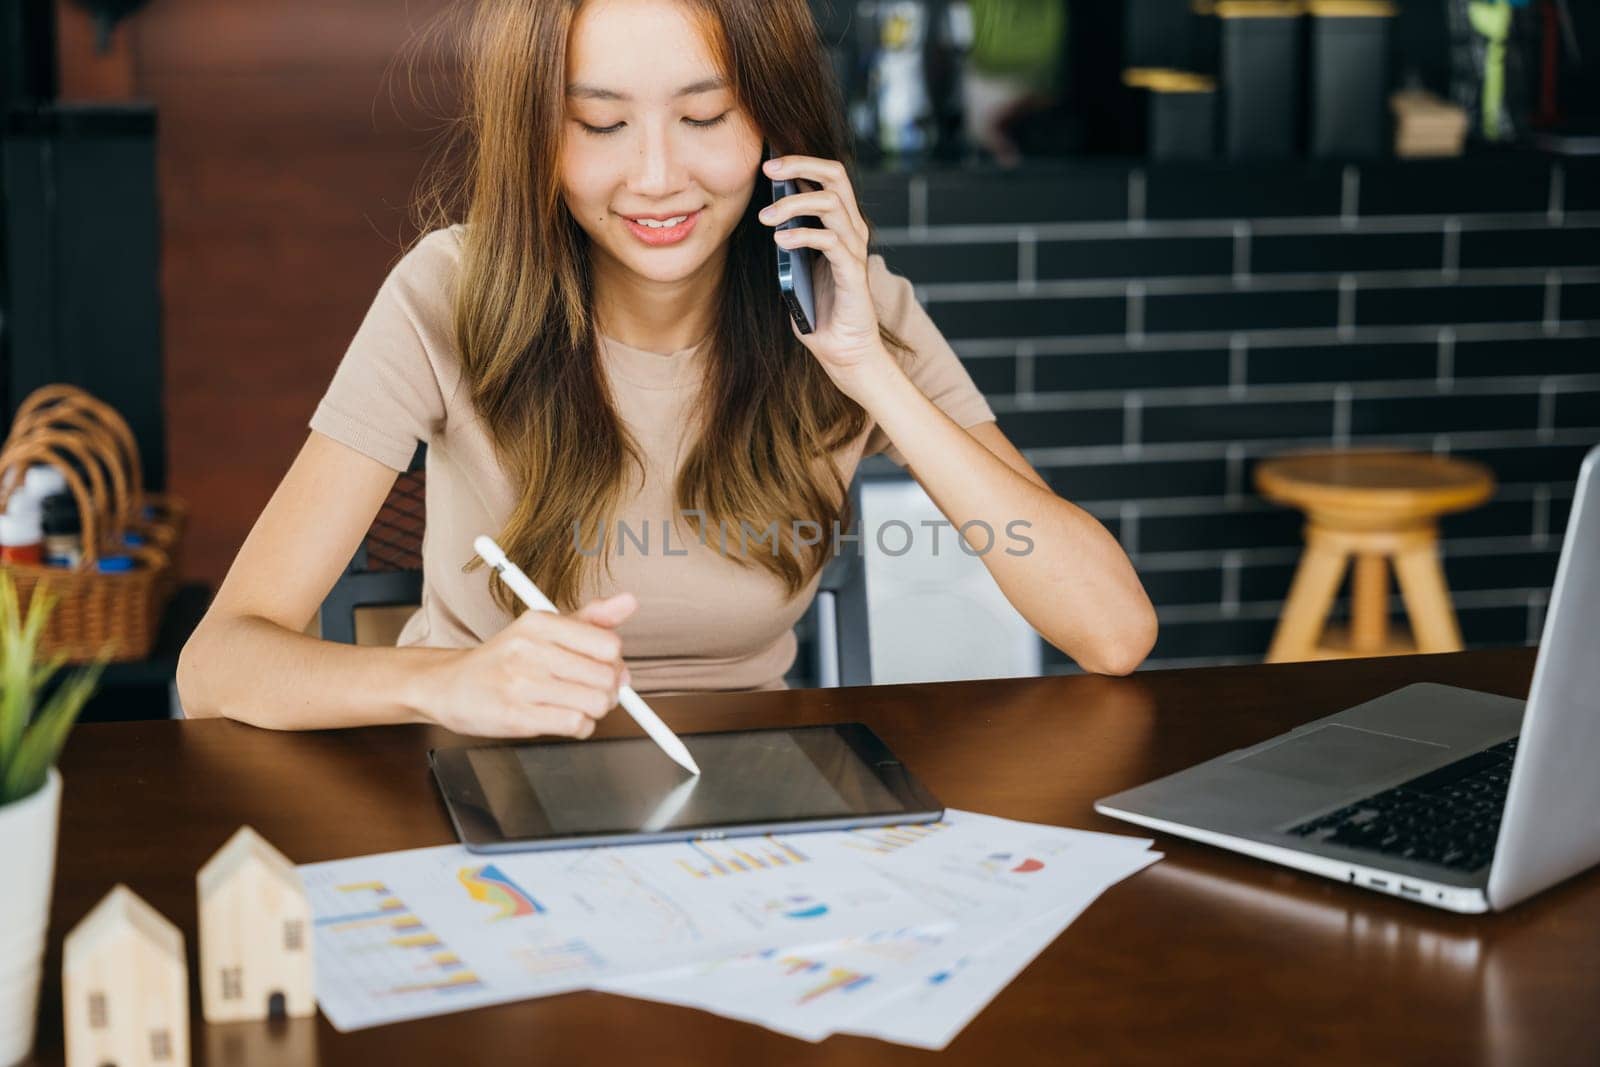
left=1288, top=737, right=1517, bottom=870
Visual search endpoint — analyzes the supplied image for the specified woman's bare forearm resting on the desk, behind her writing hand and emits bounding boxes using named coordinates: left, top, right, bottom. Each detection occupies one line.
left=178, top=616, right=459, bottom=729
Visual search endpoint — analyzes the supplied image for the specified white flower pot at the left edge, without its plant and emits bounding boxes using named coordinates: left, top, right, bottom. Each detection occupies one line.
left=0, top=768, right=61, bottom=1064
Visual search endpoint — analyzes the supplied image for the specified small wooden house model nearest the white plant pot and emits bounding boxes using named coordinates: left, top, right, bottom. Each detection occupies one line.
left=61, top=885, right=189, bottom=1067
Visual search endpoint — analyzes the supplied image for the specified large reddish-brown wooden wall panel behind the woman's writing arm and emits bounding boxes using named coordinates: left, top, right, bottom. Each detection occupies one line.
left=95, top=0, right=457, bottom=585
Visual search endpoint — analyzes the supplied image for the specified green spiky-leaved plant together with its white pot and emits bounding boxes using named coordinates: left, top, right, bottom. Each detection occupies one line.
left=0, top=571, right=106, bottom=1064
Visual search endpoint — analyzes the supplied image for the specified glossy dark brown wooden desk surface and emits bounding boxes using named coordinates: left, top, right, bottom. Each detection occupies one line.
left=25, top=649, right=1600, bottom=1067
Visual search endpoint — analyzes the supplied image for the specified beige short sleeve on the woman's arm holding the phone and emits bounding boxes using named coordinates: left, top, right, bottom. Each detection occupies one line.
left=861, top=254, right=995, bottom=467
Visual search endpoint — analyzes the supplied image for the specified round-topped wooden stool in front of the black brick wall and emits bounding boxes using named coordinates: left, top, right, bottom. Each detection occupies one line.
left=1256, top=450, right=1494, bottom=662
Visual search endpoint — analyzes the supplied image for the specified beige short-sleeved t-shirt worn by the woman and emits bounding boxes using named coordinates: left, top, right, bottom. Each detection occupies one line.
left=310, top=224, right=995, bottom=694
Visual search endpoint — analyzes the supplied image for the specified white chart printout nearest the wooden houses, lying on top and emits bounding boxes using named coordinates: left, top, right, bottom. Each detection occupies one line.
left=301, top=835, right=942, bottom=1030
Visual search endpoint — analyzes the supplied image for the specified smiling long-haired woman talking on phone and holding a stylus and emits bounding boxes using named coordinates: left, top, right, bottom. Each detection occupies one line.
left=178, top=0, right=1155, bottom=737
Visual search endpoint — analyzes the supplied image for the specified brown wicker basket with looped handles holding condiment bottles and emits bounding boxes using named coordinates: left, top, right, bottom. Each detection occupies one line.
left=0, top=386, right=187, bottom=662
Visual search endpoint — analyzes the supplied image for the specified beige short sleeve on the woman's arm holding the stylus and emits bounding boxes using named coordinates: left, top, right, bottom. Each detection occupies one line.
left=309, top=230, right=459, bottom=470
